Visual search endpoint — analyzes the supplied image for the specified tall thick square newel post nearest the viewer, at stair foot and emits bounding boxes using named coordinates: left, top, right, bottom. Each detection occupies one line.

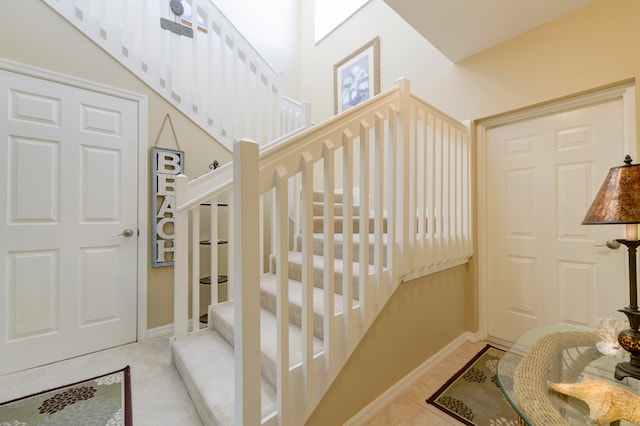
left=233, top=140, right=261, bottom=425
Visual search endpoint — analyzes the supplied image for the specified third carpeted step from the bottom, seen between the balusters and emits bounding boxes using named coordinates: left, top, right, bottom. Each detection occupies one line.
left=260, top=274, right=342, bottom=339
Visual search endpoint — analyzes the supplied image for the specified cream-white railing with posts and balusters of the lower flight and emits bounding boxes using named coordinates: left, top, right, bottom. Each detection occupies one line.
left=174, top=79, right=472, bottom=424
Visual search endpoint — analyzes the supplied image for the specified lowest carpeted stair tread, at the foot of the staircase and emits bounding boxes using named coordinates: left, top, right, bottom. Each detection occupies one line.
left=173, top=330, right=277, bottom=425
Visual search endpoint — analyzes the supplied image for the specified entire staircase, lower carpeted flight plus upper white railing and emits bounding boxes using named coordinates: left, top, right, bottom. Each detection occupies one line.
left=37, top=0, right=472, bottom=425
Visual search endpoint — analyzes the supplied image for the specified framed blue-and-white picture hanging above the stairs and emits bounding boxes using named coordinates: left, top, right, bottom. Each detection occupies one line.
left=333, top=37, right=380, bottom=114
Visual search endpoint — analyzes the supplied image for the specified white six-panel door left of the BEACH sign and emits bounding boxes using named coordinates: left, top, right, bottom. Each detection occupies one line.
left=0, top=71, right=138, bottom=374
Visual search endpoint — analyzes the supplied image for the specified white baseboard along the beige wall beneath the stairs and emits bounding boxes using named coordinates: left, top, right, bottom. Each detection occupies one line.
left=345, top=332, right=480, bottom=426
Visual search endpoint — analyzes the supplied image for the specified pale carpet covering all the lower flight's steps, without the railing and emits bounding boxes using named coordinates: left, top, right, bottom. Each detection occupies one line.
left=173, top=193, right=386, bottom=425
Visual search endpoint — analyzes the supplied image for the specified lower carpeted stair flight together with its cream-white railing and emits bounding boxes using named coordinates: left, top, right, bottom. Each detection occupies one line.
left=174, top=79, right=471, bottom=425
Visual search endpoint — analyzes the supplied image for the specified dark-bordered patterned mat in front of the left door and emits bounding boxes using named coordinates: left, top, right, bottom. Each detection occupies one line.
left=0, top=366, right=132, bottom=426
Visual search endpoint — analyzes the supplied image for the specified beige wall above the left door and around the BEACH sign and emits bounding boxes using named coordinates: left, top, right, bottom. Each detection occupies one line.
left=0, top=0, right=231, bottom=328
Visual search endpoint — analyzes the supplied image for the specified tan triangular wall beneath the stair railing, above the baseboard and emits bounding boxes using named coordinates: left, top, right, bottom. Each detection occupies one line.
left=306, top=265, right=467, bottom=426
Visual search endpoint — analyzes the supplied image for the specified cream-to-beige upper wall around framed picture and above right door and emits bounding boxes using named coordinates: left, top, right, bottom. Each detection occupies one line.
left=301, top=0, right=640, bottom=130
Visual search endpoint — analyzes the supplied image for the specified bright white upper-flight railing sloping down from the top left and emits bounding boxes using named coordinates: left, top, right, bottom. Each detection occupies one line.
left=42, top=0, right=310, bottom=149
